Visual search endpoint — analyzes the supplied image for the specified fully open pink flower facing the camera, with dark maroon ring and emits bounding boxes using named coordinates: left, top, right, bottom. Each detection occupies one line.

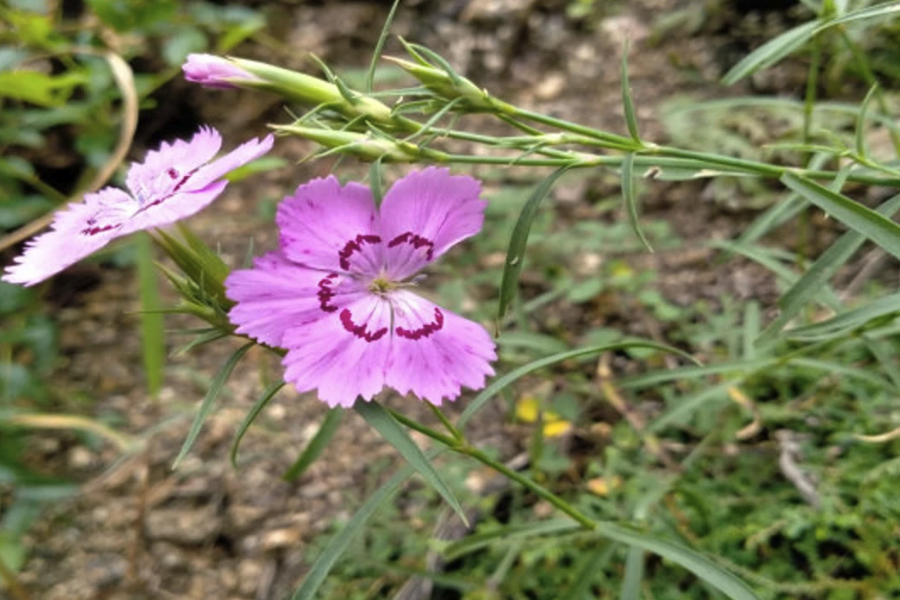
left=225, top=167, right=497, bottom=406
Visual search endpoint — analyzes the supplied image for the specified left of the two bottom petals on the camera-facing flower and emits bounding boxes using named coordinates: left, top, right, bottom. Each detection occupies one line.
left=282, top=294, right=391, bottom=407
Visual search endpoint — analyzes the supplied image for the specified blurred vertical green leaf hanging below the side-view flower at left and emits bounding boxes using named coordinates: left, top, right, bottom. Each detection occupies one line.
left=135, top=233, right=166, bottom=398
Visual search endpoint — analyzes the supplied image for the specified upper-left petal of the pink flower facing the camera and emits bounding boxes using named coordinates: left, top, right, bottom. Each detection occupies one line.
left=275, top=176, right=382, bottom=276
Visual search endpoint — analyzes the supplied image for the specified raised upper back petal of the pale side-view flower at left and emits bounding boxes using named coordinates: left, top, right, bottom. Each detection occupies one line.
left=125, top=127, right=222, bottom=203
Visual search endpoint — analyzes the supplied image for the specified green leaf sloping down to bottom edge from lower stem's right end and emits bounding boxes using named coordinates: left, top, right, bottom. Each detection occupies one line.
left=595, top=523, right=759, bottom=600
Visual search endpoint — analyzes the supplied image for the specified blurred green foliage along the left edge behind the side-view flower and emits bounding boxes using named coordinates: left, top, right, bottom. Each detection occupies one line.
left=0, top=0, right=265, bottom=584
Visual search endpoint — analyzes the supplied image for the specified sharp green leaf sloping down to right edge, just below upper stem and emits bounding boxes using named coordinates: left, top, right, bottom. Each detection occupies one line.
left=781, top=173, right=900, bottom=258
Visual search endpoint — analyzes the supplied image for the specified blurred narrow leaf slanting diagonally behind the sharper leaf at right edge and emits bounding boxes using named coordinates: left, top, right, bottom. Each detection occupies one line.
left=756, top=194, right=900, bottom=345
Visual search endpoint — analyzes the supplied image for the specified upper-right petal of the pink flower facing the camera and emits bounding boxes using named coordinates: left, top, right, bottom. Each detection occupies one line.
left=381, top=167, right=487, bottom=281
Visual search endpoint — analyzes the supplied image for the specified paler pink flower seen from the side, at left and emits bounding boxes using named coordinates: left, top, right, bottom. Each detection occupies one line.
left=2, top=127, right=273, bottom=286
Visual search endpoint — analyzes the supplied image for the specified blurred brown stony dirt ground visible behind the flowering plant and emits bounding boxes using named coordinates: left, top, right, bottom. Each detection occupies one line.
left=0, top=0, right=816, bottom=600
